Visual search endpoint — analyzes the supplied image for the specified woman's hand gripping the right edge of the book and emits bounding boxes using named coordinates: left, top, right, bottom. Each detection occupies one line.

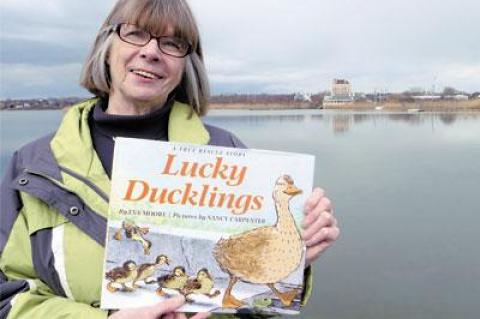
left=302, top=187, right=340, bottom=266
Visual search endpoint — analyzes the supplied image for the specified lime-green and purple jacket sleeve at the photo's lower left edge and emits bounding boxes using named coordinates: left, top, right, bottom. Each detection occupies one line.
left=0, top=154, right=107, bottom=319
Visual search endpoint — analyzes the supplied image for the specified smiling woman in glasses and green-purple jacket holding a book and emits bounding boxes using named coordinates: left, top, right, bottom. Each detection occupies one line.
left=0, top=0, right=339, bottom=319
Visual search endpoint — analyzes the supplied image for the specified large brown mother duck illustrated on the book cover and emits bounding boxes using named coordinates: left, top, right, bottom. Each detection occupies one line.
left=213, top=175, right=303, bottom=308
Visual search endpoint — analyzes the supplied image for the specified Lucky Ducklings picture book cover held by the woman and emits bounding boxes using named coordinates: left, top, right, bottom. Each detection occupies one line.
left=101, top=138, right=314, bottom=314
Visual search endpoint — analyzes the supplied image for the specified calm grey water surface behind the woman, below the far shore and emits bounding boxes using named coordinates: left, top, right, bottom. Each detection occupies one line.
left=0, top=111, right=480, bottom=319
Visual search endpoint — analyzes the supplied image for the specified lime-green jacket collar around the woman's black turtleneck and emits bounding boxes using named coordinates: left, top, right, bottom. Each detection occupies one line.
left=50, top=98, right=210, bottom=200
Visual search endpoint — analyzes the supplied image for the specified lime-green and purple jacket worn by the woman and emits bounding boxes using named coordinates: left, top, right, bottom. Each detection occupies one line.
left=0, top=99, right=312, bottom=319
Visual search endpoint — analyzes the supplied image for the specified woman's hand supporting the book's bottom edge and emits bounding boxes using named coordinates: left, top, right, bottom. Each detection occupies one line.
left=108, top=296, right=210, bottom=319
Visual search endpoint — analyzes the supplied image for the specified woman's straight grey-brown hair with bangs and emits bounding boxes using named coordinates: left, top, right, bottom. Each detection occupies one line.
left=80, top=0, right=209, bottom=115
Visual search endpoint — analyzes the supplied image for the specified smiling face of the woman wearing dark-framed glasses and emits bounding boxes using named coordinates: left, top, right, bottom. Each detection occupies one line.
left=108, top=27, right=185, bottom=114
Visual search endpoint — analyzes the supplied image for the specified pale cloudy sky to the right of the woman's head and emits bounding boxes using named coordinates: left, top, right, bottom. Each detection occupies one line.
left=190, top=0, right=480, bottom=92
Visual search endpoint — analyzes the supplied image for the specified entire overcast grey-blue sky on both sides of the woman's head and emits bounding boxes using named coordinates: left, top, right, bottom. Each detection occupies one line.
left=0, top=0, right=480, bottom=98
